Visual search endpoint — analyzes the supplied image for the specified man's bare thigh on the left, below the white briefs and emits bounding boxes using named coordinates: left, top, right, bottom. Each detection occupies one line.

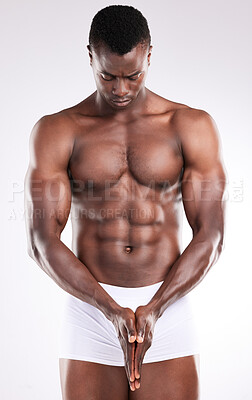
left=59, top=358, right=129, bottom=400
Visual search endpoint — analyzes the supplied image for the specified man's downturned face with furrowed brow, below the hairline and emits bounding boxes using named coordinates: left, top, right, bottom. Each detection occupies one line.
left=87, top=43, right=152, bottom=110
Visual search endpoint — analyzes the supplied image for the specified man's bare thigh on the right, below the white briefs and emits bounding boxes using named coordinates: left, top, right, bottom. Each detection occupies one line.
left=129, top=355, right=199, bottom=400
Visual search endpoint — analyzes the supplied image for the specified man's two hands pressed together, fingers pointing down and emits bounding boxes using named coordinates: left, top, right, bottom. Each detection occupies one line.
left=113, top=306, right=157, bottom=391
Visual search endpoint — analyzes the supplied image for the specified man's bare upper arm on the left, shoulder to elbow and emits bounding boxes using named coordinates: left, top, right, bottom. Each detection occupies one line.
left=25, top=114, right=71, bottom=242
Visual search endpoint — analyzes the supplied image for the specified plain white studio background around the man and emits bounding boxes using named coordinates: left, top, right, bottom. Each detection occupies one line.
left=0, top=0, right=252, bottom=400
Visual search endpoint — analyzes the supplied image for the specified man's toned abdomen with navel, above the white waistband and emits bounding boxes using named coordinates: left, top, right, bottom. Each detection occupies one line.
left=72, top=204, right=180, bottom=287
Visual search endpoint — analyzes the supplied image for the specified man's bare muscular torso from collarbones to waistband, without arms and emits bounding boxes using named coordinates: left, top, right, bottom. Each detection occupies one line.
left=64, top=89, right=185, bottom=287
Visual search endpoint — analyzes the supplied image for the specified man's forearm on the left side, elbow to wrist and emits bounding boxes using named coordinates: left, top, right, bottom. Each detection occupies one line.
left=30, top=236, right=120, bottom=320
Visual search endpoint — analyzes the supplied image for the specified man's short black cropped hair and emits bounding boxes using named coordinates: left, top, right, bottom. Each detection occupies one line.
left=89, top=5, right=151, bottom=55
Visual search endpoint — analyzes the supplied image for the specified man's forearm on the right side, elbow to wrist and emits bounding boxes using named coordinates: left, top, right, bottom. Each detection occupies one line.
left=148, top=232, right=222, bottom=318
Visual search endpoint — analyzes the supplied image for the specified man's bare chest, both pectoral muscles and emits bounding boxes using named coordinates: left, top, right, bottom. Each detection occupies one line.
left=70, top=120, right=183, bottom=189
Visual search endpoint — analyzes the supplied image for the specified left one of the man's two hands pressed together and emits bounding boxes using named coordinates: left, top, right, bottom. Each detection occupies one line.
left=112, top=307, right=138, bottom=390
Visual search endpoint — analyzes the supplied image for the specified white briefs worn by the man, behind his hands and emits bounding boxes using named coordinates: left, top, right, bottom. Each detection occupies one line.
left=59, top=281, right=200, bottom=366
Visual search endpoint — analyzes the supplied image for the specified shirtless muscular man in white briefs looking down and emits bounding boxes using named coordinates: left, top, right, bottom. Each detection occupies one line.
left=25, top=6, right=226, bottom=400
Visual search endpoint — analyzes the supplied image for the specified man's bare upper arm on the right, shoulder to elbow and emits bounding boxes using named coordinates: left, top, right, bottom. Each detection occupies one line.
left=178, top=109, right=226, bottom=233
